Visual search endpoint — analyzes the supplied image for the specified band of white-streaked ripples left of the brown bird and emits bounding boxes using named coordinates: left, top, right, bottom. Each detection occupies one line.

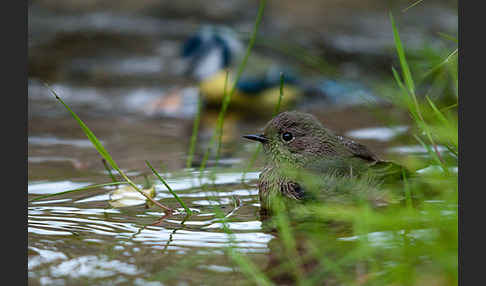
left=28, top=173, right=271, bottom=245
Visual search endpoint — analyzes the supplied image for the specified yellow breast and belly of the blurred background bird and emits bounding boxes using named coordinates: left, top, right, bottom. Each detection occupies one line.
left=199, top=70, right=300, bottom=112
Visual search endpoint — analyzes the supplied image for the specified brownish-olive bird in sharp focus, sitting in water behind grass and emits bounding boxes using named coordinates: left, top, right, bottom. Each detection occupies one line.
left=243, top=111, right=406, bottom=211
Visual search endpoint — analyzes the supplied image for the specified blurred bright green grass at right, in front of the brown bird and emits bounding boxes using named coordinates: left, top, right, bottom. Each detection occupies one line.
left=221, top=10, right=458, bottom=285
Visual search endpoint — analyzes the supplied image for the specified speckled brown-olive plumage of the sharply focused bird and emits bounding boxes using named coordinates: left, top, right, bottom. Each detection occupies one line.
left=246, top=111, right=400, bottom=209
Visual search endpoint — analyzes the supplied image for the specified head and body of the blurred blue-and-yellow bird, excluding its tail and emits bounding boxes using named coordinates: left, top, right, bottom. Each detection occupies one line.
left=181, top=26, right=304, bottom=114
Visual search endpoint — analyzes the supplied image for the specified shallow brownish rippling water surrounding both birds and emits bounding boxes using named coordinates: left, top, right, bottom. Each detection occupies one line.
left=27, top=1, right=457, bottom=286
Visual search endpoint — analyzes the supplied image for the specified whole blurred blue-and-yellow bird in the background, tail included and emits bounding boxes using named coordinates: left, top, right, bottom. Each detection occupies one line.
left=181, top=26, right=376, bottom=112
